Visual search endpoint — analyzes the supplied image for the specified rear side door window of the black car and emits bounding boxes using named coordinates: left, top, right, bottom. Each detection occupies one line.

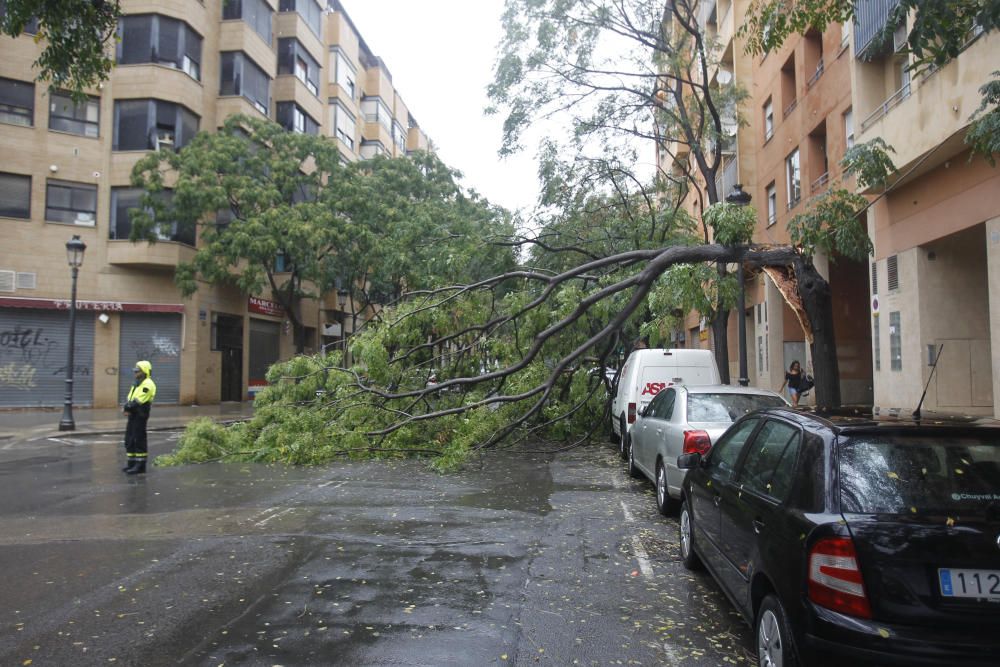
left=739, top=421, right=801, bottom=500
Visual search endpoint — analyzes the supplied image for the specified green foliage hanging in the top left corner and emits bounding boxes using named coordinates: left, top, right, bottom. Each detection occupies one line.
left=0, top=0, right=122, bottom=102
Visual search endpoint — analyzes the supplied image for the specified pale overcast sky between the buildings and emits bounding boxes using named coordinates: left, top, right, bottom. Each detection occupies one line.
left=341, top=0, right=538, bottom=209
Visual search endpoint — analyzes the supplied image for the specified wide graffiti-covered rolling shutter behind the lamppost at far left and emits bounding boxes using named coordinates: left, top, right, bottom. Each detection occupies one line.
left=0, top=308, right=94, bottom=407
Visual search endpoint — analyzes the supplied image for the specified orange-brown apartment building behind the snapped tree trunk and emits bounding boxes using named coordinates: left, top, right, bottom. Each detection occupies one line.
left=743, top=13, right=872, bottom=404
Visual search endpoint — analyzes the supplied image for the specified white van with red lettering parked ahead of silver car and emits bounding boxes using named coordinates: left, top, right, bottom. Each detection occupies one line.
left=611, top=348, right=722, bottom=455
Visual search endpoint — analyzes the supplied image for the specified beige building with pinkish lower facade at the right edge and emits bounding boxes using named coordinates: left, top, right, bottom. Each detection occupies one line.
left=851, top=0, right=1000, bottom=416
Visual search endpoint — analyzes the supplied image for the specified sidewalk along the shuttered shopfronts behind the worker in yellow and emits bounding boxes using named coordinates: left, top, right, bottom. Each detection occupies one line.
left=0, top=401, right=253, bottom=446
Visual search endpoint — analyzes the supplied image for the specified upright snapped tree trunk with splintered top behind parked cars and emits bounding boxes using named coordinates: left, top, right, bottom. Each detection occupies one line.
left=795, top=258, right=840, bottom=408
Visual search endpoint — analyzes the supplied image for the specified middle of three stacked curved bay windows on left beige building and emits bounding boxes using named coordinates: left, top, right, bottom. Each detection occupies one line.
left=112, top=99, right=199, bottom=151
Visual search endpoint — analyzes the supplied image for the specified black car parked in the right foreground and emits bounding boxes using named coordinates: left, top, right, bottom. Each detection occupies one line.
left=678, top=408, right=1000, bottom=667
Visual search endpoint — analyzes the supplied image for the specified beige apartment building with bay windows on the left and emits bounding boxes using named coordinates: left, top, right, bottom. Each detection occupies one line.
left=0, top=0, right=429, bottom=408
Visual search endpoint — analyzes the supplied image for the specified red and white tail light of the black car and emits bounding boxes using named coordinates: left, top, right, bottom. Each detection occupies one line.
left=809, top=537, right=872, bottom=618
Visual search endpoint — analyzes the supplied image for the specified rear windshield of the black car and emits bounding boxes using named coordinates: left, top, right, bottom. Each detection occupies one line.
left=839, top=431, right=1000, bottom=517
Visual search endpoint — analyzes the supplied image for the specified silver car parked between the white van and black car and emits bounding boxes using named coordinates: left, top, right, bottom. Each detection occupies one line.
left=627, top=384, right=788, bottom=514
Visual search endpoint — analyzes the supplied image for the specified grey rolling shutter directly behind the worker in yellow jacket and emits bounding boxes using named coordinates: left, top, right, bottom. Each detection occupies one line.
left=118, top=313, right=181, bottom=404
